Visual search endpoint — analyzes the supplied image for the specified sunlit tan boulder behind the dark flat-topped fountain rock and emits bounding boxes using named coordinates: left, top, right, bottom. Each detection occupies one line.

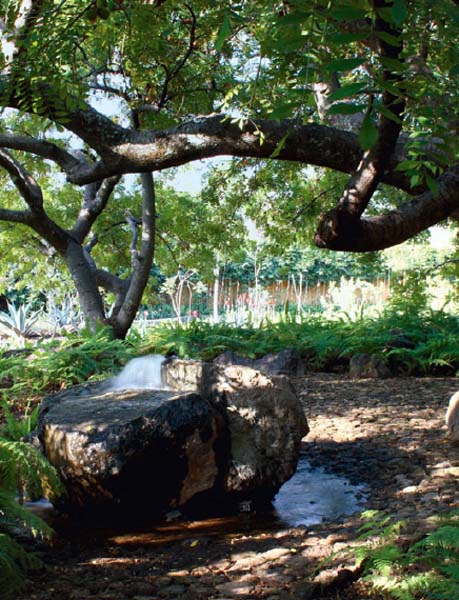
left=163, top=358, right=309, bottom=499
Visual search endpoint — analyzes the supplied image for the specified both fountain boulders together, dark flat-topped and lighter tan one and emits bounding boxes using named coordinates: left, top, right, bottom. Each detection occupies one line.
left=39, top=359, right=308, bottom=517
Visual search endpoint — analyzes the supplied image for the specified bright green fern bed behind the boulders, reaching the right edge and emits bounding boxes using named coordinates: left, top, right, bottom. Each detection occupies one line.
left=142, top=310, right=459, bottom=375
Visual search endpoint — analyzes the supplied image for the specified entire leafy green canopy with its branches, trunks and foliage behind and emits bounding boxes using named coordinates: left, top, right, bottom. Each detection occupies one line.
left=0, top=0, right=459, bottom=337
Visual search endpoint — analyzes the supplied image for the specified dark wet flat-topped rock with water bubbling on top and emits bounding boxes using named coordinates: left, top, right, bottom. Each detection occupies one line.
left=39, top=389, right=227, bottom=515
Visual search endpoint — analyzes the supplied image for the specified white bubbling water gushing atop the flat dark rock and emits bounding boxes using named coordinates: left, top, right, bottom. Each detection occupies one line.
left=108, top=354, right=167, bottom=392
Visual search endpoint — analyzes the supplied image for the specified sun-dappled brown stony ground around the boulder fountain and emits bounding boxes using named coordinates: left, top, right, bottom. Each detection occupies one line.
left=17, top=374, right=459, bottom=600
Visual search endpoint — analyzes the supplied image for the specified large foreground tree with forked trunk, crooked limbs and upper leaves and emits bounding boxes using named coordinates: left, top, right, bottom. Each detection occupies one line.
left=0, top=0, right=459, bottom=335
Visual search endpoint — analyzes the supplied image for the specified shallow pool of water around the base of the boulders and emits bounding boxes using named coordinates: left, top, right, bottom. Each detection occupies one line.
left=28, top=457, right=366, bottom=546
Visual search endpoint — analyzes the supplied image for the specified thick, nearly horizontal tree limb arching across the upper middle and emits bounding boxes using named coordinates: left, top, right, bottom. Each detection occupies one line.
left=60, top=115, right=412, bottom=191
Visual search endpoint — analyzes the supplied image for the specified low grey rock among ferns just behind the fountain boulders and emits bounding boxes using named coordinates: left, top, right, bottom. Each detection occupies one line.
left=214, top=348, right=305, bottom=377
